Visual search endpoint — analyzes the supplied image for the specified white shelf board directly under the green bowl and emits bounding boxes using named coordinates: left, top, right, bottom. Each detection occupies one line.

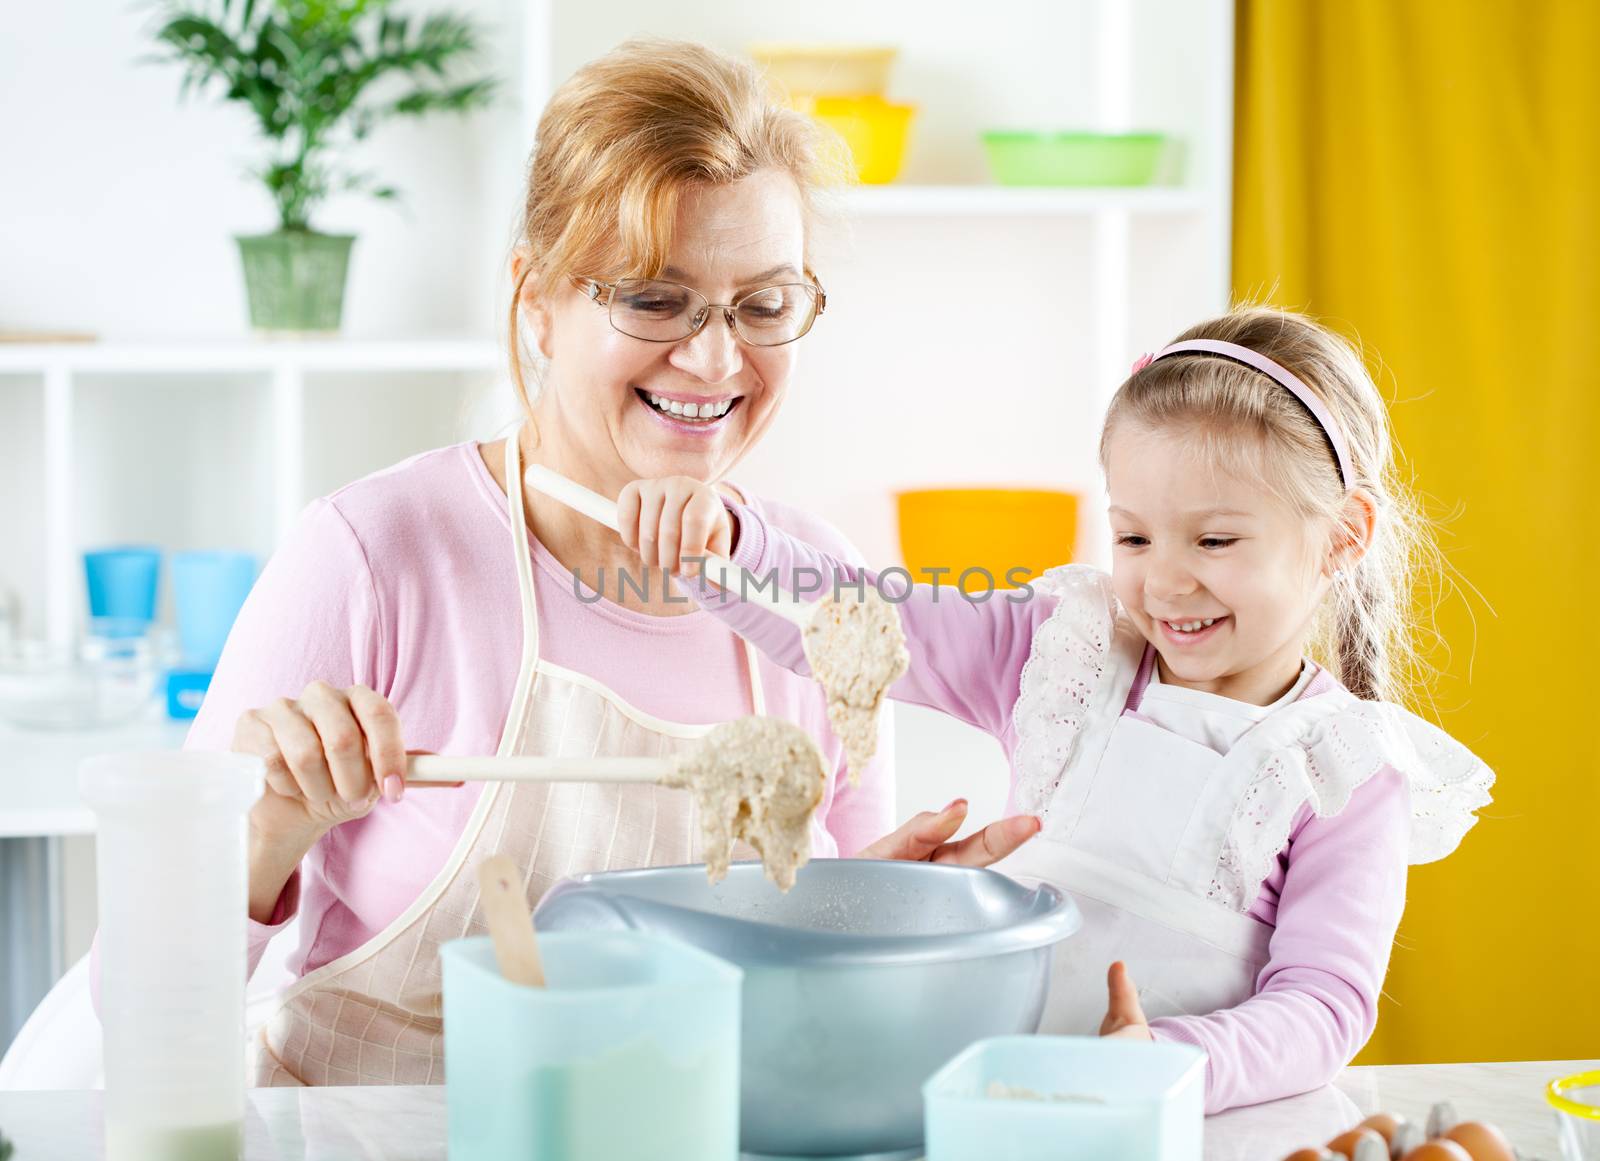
left=842, top=186, right=1206, bottom=217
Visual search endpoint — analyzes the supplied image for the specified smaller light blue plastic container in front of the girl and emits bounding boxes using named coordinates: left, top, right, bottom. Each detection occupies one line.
left=922, top=1036, right=1205, bottom=1161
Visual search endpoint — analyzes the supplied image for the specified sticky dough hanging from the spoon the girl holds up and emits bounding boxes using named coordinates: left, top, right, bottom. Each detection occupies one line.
left=800, top=588, right=910, bottom=785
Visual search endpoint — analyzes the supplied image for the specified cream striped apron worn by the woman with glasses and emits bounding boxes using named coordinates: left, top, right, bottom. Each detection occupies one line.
left=253, top=435, right=774, bottom=1086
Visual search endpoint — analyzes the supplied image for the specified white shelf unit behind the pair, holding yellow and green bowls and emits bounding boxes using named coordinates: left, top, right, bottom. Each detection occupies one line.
left=520, top=0, right=1234, bottom=575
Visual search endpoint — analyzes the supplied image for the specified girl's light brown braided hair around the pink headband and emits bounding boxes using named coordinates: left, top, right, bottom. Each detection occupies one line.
left=1101, top=307, right=1438, bottom=700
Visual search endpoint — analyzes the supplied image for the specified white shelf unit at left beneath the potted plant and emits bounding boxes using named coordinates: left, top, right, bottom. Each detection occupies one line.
left=0, top=339, right=504, bottom=643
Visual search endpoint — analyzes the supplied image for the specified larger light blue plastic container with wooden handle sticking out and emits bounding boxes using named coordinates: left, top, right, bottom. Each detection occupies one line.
left=440, top=931, right=744, bottom=1161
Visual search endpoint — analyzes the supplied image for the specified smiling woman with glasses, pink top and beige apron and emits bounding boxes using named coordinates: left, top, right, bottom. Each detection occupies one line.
left=189, top=43, right=1037, bottom=1084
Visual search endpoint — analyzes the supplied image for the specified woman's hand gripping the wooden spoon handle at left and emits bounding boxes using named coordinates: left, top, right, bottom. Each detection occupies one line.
left=232, top=681, right=419, bottom=923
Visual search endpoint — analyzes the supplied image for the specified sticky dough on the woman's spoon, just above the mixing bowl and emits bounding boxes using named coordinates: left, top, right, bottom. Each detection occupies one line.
left=669, top=718, right=827, bottom=891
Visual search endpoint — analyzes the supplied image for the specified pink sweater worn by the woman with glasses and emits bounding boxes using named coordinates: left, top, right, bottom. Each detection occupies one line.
left=187, top=443, right=894, bottom=974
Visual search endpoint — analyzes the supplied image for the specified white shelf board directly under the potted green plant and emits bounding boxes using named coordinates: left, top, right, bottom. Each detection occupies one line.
left=0, top=339, right=506, bottom=374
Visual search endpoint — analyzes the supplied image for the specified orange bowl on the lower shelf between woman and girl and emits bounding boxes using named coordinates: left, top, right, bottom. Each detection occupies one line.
left=894, top=488, right=1078, bottom=595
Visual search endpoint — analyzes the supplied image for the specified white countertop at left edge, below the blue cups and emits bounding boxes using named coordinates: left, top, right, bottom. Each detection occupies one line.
left=0, top=712, right=189, bottom=838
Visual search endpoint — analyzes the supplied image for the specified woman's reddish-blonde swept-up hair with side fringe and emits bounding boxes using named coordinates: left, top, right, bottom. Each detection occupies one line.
left=510, top=40, right=838, bottom=408
